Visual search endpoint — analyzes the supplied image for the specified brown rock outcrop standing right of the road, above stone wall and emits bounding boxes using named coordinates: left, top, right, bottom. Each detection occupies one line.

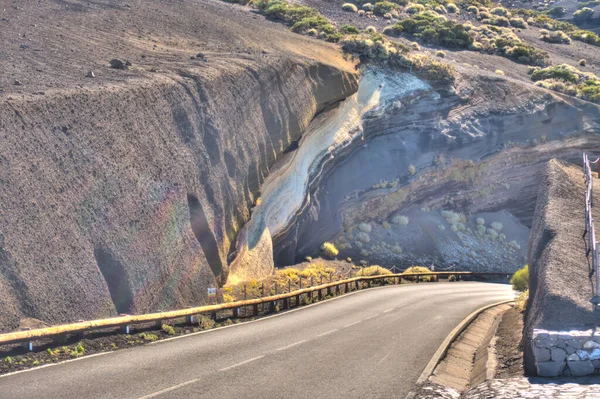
left=524, top=159, right=600, bottom=375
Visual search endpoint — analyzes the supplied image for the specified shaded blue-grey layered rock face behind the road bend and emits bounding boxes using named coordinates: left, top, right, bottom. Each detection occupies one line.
left=275, top=71, right=599, bottom=272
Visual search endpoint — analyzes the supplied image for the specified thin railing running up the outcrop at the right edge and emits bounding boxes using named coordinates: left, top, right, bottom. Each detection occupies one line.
left=583, top=153, right=600, bottom=306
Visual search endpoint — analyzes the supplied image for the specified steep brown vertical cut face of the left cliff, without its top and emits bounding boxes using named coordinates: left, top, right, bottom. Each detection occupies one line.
left=0, top=42, right=357, bottom=331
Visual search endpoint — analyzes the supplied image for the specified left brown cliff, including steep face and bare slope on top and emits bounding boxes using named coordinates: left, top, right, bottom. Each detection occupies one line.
left=0, top=1, right=357, bottom=331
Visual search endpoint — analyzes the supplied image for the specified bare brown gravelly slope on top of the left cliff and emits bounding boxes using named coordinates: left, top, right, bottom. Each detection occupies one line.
left=0, top=0, right=352, bottom=101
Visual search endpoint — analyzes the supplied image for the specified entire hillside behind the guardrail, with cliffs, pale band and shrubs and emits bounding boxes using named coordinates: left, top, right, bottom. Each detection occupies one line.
left=0, top=0, right=600, bottom=331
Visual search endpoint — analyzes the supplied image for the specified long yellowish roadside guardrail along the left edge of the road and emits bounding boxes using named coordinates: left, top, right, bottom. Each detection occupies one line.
left=0, top=272, right=509, bottom=351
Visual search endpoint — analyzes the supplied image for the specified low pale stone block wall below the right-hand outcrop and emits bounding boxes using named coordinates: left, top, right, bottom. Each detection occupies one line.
left=533, top=329, right=600, bottom=377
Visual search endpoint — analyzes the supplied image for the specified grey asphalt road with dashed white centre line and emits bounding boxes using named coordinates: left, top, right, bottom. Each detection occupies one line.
left=0, top=282, right=513, bottom=399
